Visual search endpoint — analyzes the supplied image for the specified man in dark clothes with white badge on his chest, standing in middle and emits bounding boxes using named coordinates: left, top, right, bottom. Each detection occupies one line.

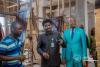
left=37, top=19, right=64, bottom=67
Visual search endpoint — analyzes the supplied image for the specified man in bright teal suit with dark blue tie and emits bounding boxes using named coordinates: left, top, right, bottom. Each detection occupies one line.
left=62, top=18, right=87, bottom=67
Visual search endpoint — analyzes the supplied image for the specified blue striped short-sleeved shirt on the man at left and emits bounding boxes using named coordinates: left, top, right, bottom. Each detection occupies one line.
left=0, top=35, right=22, bottom=67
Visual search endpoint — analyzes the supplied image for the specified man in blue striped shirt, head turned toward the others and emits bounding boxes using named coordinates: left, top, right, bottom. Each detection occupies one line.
left=0, top=22, right=25, bottom=67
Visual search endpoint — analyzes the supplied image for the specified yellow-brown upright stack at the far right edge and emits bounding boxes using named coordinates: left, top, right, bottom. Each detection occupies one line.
left=95, top=9, right=100, bottom=67
